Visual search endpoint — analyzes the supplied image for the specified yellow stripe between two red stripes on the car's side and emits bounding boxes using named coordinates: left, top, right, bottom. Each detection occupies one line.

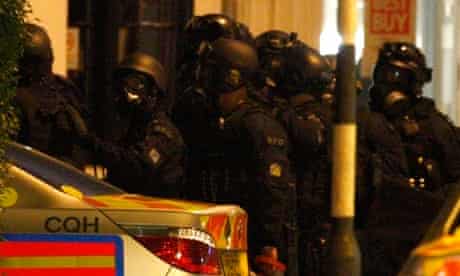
left=0, top=256, right=115, bottom=268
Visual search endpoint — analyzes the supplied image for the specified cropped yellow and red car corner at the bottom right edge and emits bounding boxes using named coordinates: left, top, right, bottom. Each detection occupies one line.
left=398, top=183, right=460, bottom=276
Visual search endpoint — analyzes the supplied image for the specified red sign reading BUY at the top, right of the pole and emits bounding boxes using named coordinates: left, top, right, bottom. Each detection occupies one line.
left=369, top=0, right=413, bottom=35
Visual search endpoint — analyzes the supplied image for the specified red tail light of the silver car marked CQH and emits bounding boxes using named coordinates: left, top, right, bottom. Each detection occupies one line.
left=129, top=229, right=221, bottom=275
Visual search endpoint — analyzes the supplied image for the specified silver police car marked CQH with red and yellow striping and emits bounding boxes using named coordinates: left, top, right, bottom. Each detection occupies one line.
left=0, top=143, right=249, bottom=276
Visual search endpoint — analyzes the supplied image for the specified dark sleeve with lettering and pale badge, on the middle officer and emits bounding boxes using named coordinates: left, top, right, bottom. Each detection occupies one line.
left=245, top=113, right=297, bottom=266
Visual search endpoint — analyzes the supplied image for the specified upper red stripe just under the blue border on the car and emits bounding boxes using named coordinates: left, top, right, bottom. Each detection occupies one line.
left=0, top=241, right=116, bottom=256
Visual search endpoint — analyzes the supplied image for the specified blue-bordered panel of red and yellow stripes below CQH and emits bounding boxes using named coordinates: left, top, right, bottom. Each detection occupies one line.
left=0, top=234, right=124, bottom=276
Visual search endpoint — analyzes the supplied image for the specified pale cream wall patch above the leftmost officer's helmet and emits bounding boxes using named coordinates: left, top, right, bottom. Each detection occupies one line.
left=28, top=0, right=68, bottom=75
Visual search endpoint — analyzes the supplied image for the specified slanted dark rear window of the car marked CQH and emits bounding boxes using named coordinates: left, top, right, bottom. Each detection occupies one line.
left=6, top=142, right=124, bottom=196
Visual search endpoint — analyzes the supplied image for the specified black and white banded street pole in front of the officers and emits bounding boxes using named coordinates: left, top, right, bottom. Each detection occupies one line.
left=324, top=0, right=361, bottom=276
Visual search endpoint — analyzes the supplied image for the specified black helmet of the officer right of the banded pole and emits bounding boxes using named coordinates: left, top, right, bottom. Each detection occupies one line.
left=373, top=42, right=431, bottom=89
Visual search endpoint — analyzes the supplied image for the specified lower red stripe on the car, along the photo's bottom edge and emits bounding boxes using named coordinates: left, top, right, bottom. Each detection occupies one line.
left=0, top=268, right=116, bottom=276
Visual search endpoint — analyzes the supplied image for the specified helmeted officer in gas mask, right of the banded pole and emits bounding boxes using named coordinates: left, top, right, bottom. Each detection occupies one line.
left=370, top=42, right=460, bottom=194
